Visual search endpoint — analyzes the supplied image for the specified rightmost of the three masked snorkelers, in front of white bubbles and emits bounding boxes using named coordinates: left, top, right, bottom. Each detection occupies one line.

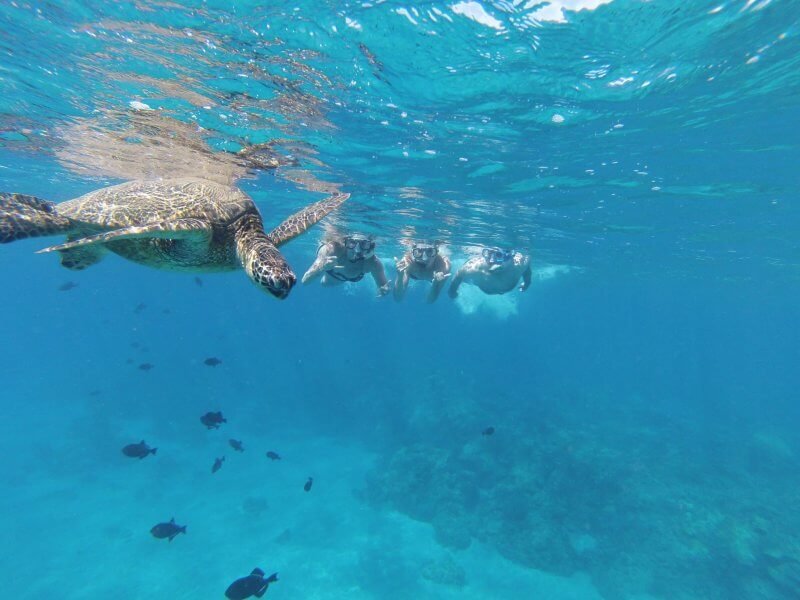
left=448, top=248, right=531, bottom=298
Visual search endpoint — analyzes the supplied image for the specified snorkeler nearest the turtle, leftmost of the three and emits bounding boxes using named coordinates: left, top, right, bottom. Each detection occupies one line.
left=303, top=233, right=389, bottom=296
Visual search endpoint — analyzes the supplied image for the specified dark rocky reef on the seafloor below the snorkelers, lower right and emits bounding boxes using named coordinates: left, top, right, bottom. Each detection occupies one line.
left=364, top=390, right=800, bottom=600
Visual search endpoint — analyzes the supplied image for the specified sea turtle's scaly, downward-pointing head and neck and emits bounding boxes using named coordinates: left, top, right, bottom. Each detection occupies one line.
left=236, top=223, right=297, bottom=300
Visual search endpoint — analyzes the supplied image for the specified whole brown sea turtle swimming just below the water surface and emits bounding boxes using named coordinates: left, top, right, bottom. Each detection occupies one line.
left=0, top=178, right=349, bottom=299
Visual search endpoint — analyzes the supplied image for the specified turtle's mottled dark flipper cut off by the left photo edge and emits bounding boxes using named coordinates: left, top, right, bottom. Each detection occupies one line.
left=0, top=192, right=72, bottom=244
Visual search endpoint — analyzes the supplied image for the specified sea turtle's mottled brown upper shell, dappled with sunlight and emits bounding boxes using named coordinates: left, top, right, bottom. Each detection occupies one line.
left=56, top=179, right=256, bottom=229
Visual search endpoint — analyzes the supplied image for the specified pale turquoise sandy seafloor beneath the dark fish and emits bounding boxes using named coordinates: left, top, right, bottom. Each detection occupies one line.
left=1, top=431, right=601, bottom=600
